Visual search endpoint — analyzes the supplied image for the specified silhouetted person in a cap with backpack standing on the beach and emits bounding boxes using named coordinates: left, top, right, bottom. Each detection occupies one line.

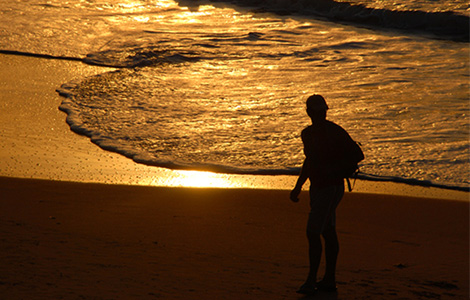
left=290, top=95, right=363, bottom=294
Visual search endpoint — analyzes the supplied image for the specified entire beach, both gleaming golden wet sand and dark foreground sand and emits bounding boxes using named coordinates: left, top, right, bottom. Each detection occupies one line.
left=0, top=55, right=469, bottom=299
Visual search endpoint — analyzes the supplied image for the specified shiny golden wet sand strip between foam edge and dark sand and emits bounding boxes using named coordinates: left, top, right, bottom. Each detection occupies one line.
left=0, top=54, right=470, bottom=201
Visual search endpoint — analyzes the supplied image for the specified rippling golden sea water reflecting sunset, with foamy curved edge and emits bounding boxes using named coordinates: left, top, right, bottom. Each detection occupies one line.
left=0, top=0, right=470, bottom=190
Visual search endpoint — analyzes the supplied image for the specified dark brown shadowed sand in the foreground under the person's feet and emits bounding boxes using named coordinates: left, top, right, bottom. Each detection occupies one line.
left=0, top=178, right=469, bottom=299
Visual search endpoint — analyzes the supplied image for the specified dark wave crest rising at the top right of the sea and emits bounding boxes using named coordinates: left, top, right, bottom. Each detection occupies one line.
left=207, top=0, right=470, bottom=42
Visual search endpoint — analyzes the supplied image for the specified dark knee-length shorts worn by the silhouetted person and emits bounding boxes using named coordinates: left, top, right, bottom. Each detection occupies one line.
left=307, top=185, right=344, bottom=235
